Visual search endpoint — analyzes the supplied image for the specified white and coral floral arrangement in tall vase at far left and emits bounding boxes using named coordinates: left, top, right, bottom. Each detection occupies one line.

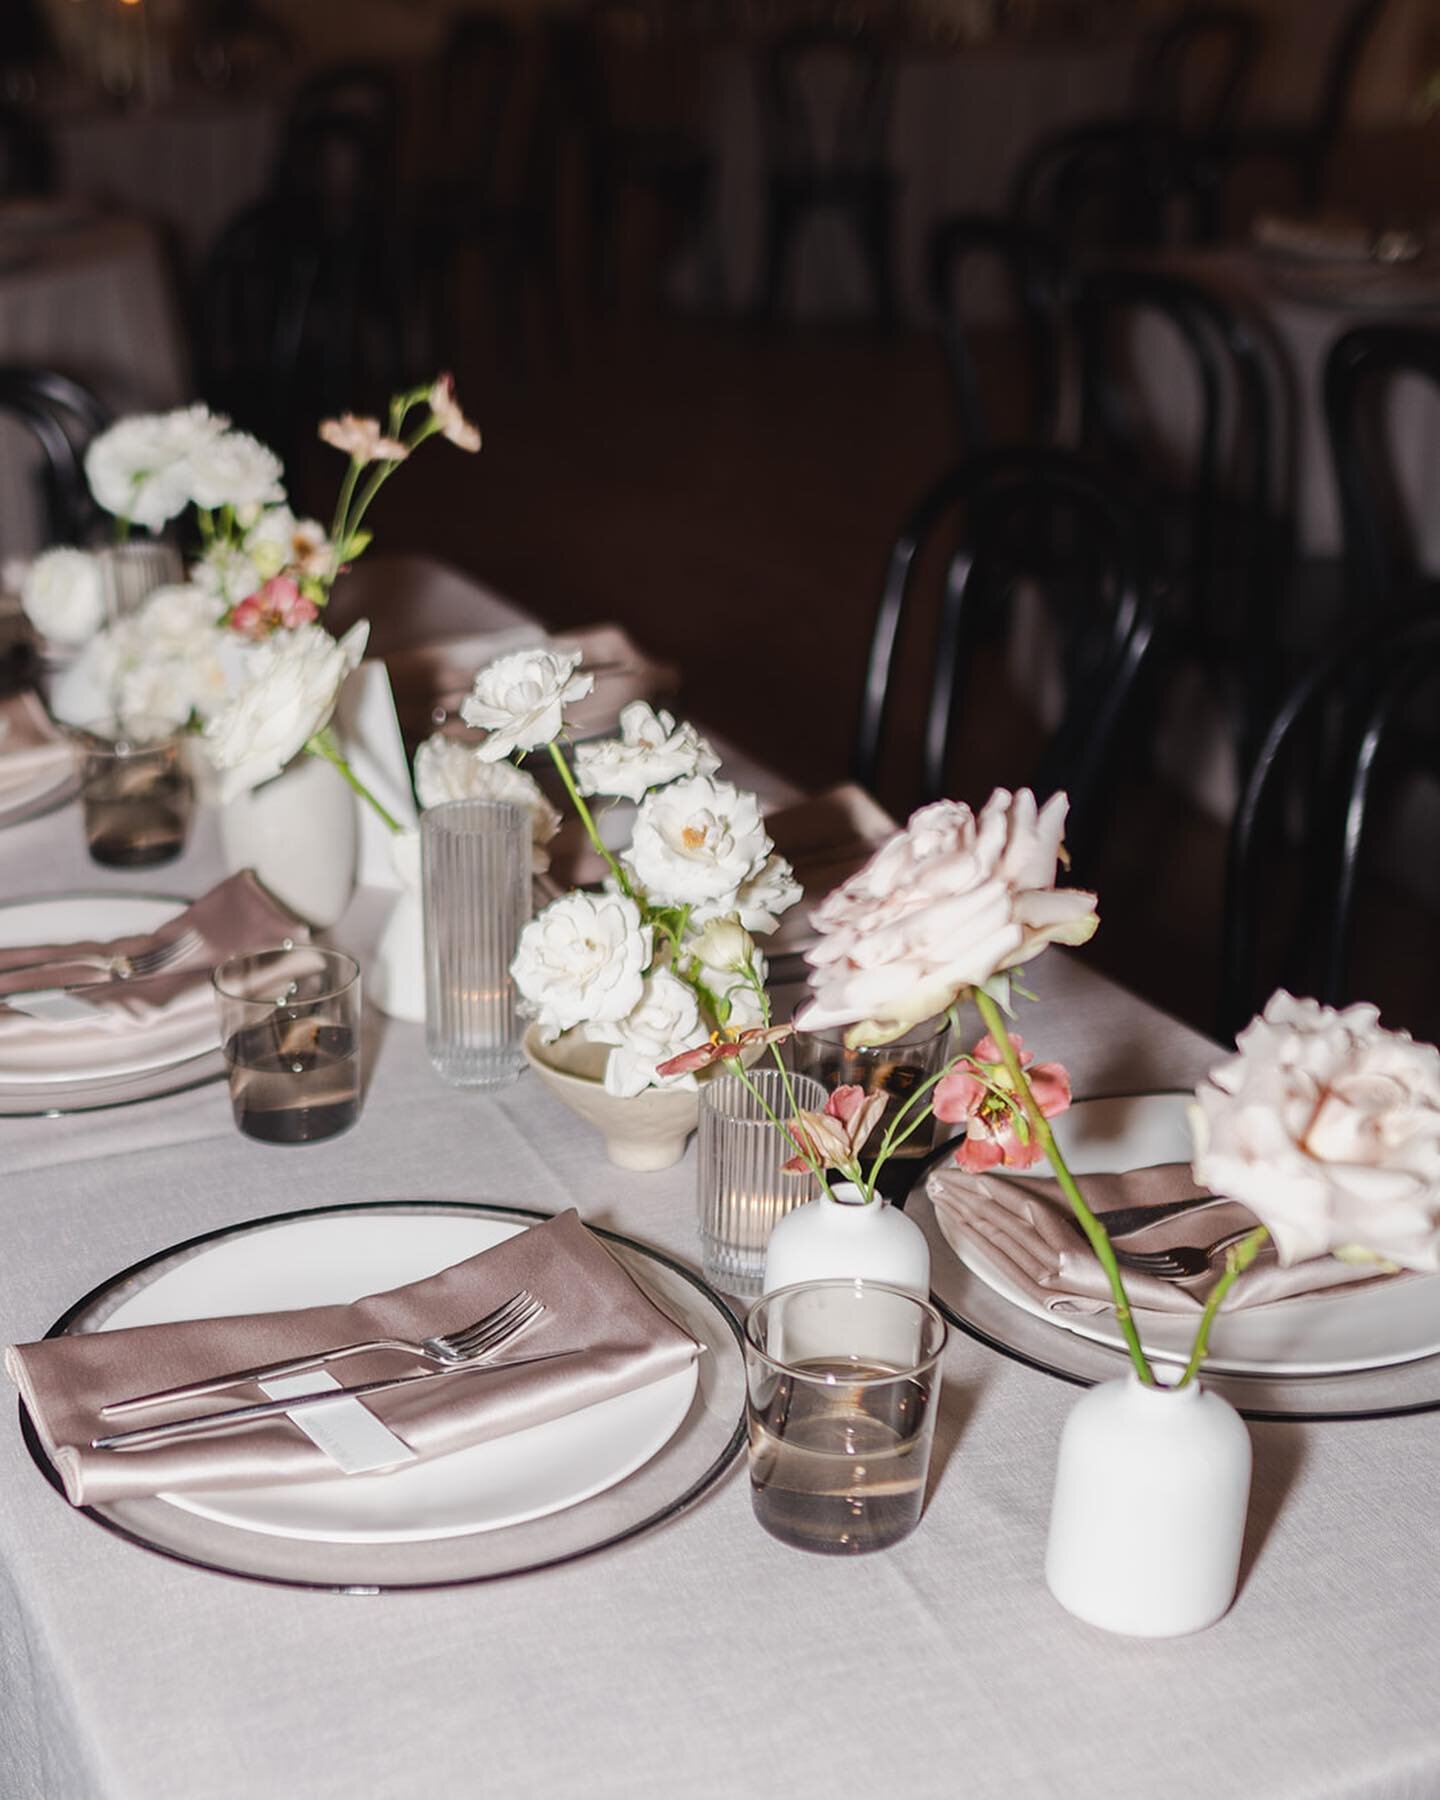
left=22, top=374, right=481, bottom=832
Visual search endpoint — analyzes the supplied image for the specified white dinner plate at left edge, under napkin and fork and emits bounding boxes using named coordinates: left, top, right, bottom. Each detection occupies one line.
left=0, top=893, right=220, bottom=1096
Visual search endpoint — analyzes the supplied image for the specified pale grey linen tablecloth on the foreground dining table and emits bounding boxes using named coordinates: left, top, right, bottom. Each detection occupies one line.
left=0, top=578, right=1440, bottom=1800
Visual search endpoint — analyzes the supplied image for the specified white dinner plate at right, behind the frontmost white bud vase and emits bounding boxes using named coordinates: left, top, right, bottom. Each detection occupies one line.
left=941, top=1094, right=1440, bottom=1375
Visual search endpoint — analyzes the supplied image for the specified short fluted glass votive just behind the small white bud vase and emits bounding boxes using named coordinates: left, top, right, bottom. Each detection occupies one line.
left=697, top=1067, right=826, bottom=1298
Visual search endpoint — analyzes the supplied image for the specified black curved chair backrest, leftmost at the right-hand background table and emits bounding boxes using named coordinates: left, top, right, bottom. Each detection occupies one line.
left=929, top=212, right=1062, bottom=454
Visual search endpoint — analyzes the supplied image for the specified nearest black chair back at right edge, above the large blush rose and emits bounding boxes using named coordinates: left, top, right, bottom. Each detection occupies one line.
left=1217, top=617, right=1440, bottom=1042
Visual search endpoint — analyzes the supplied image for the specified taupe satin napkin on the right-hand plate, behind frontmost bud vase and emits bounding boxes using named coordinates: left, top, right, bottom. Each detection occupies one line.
left=925, top=1163, right=1384, bottom=1312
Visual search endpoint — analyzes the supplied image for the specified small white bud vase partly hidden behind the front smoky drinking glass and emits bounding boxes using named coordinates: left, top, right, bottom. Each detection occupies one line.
left=761, top=1181, right=931, bottom=1300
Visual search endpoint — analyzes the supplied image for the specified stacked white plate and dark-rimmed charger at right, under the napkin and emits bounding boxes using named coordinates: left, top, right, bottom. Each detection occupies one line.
left=907, top=1094, right=1440, bottom=1418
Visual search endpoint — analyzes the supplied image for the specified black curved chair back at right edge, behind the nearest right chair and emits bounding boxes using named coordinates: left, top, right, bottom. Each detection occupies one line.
left=1325, top=324, right=1440, bottom=616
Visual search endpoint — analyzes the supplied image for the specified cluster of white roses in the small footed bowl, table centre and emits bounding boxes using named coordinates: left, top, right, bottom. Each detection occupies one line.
left=444, top=650, right=801, bottom=1096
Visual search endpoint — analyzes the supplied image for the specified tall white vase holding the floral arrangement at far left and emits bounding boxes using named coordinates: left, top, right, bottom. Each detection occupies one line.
left=220, top=756, right=360, bottom=927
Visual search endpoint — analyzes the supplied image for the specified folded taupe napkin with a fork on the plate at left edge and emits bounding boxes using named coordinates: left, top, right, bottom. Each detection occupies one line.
left=0, top=869, right=310, bottom=1080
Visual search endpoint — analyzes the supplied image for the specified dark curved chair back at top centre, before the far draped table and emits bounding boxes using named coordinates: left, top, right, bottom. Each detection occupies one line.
left=760, top=25, right=895, bottom=175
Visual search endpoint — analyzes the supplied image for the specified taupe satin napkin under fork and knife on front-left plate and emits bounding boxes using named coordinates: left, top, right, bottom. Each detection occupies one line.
left=5, top=1210, right=698, bottom=1507
